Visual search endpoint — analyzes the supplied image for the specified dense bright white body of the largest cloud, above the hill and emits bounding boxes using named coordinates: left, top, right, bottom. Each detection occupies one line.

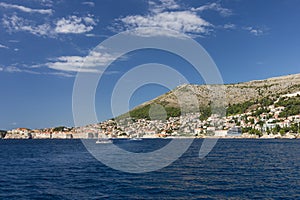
left=120, top=11, right=212, bottom=36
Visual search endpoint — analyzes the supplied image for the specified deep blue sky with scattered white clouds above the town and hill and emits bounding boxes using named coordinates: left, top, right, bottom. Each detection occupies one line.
left=0, top=0, right=300, bottom=130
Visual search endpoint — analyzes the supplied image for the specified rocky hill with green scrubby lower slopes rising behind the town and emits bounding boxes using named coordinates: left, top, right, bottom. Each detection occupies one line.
left=121, top=74, right=300, bottom=119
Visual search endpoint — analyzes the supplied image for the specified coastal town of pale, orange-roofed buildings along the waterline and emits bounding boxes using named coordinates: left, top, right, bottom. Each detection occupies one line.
left=0, top=92, right=300, bottom=139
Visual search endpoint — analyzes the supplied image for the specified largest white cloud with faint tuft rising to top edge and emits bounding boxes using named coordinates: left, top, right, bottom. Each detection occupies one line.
left=116, top=0, right=214, bottom=37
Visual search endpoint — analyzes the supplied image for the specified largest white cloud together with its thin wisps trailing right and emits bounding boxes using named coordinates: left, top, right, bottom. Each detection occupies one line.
left=110, top=0, right=269, bottom=38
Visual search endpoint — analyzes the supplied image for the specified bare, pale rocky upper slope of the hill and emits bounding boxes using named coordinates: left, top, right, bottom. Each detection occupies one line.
left=133, top=74, right=300, bottom=115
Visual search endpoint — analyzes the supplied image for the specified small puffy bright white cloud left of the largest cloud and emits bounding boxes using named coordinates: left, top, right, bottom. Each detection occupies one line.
left=55, top=15, right=96, bottom=34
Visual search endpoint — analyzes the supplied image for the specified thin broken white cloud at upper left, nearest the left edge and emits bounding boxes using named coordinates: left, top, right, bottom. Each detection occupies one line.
left=2, top=14, right=51, bottom=36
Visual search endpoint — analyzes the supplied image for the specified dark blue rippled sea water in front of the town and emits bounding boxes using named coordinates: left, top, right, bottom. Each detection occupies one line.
left=0, top=139, right=300, bottom=199
